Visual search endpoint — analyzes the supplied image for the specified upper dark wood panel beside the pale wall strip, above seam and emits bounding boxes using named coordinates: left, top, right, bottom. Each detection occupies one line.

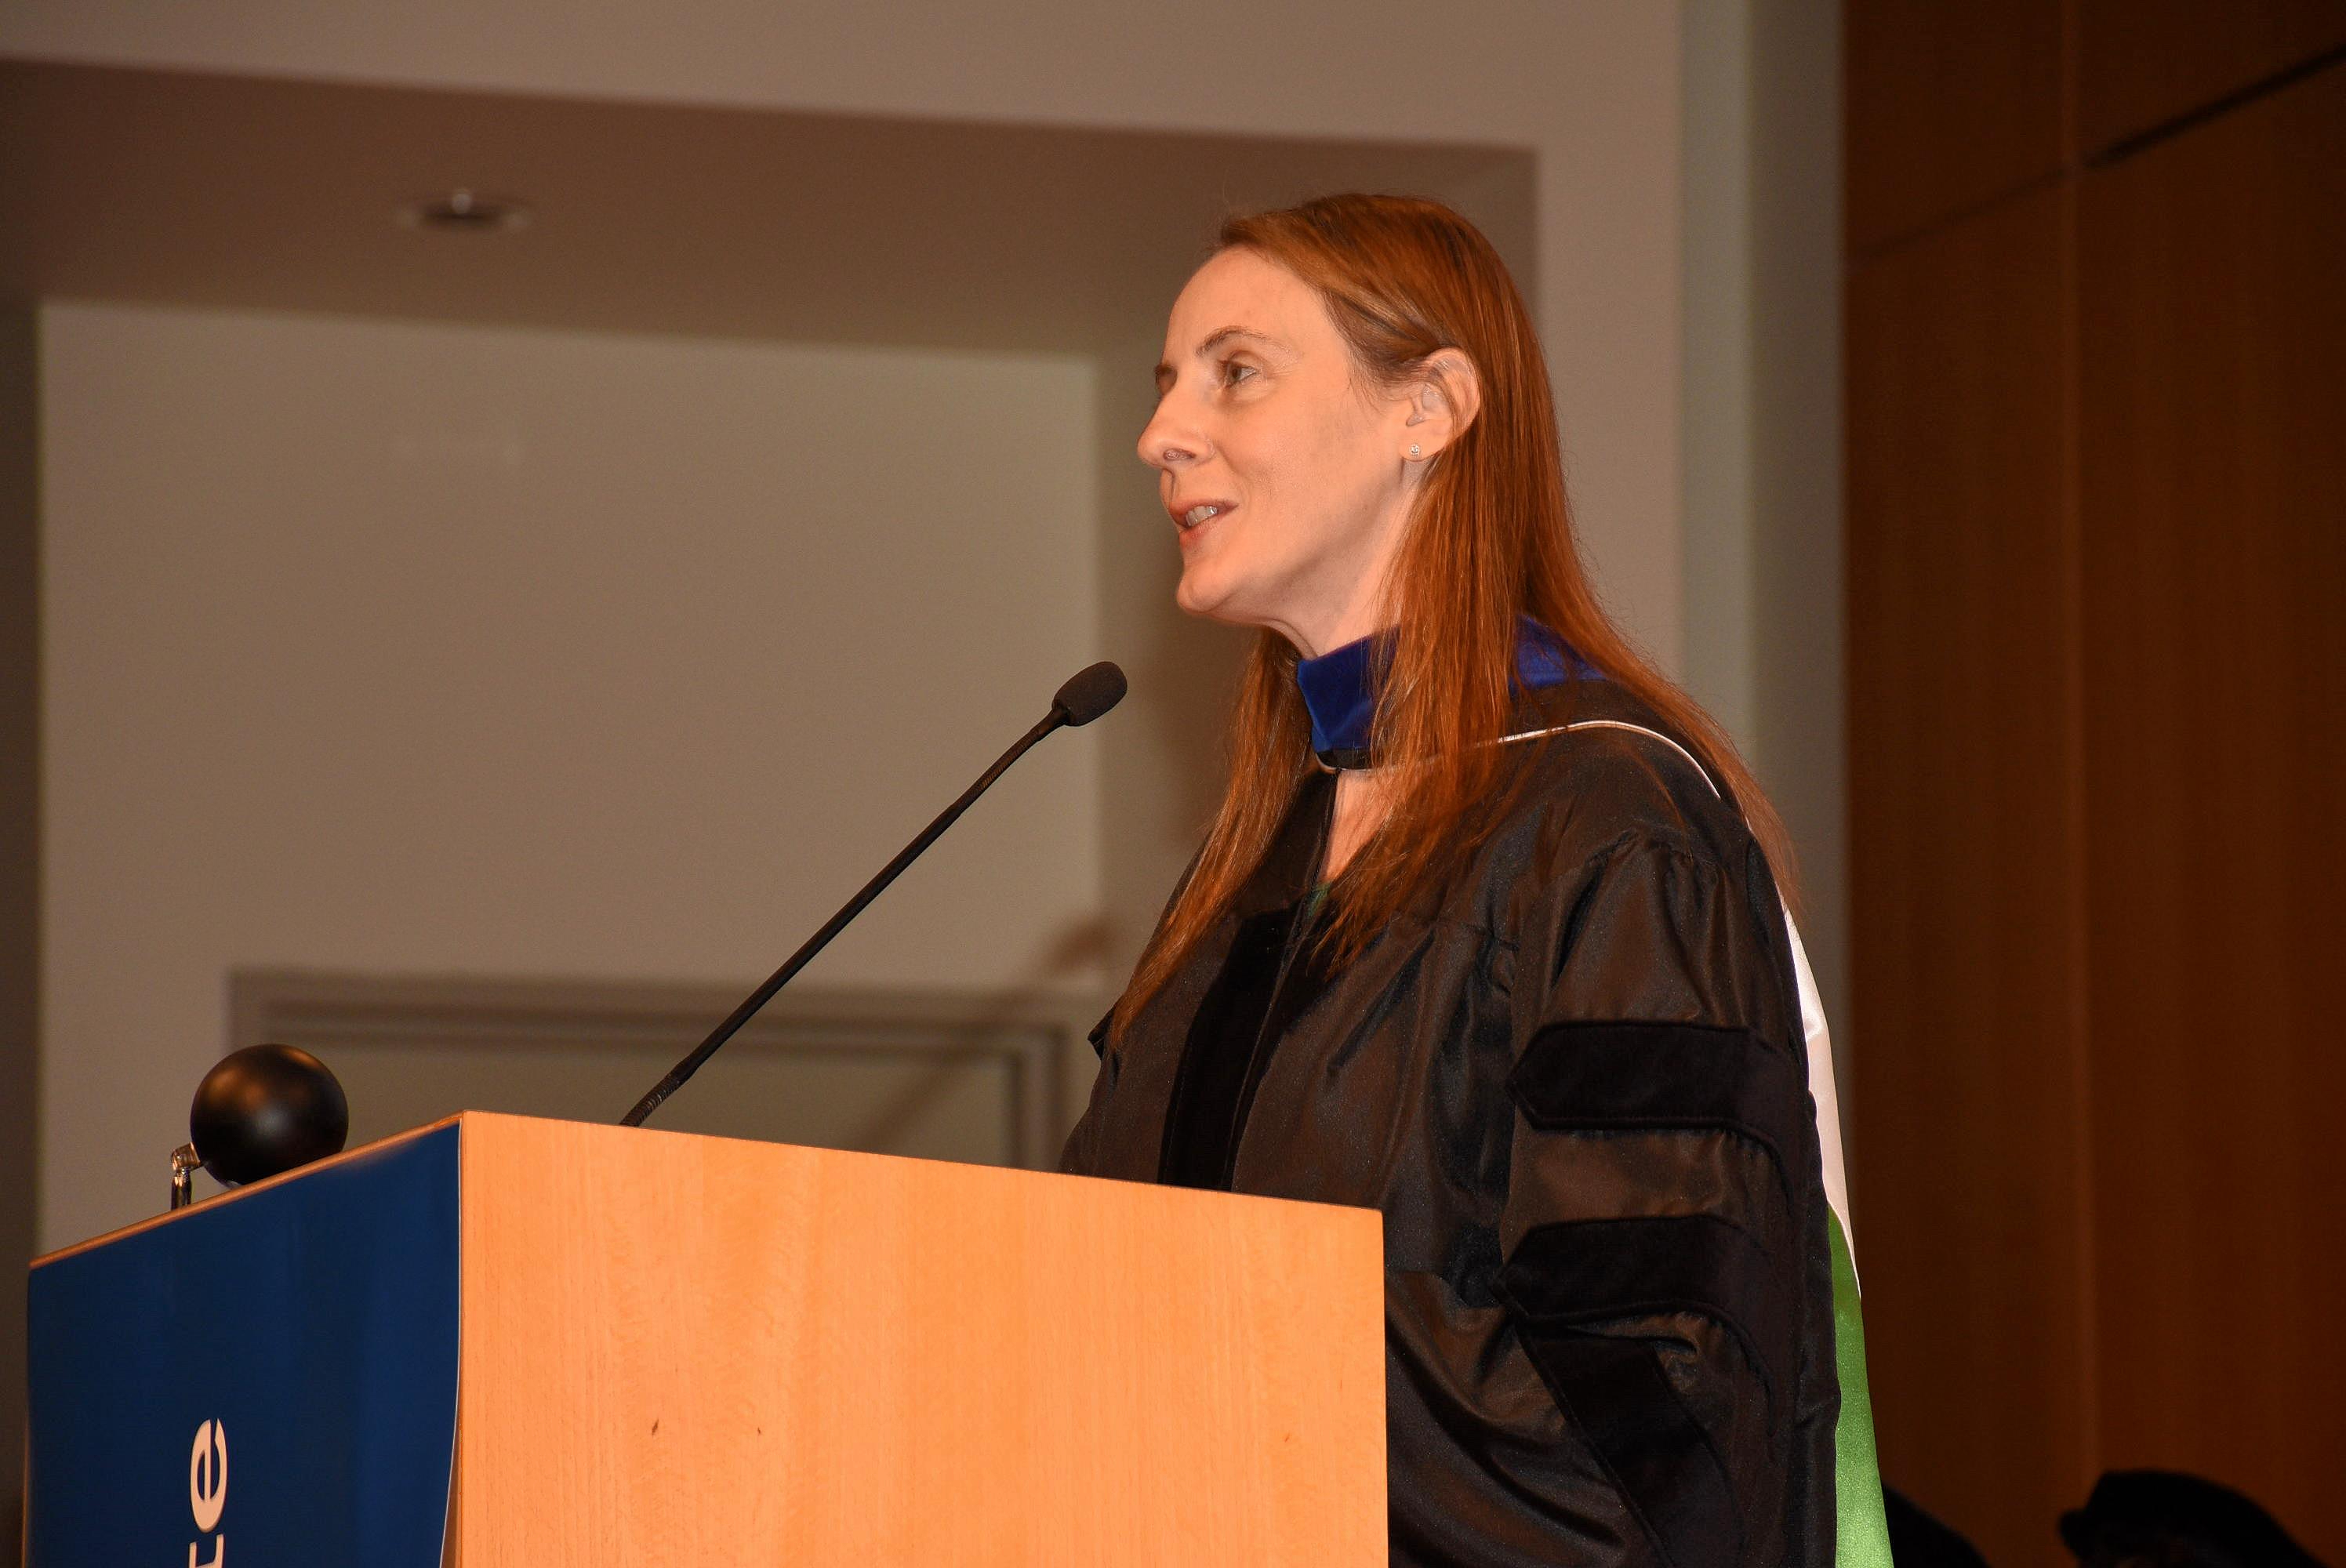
left=1842, top=0, right=2065, bottom=253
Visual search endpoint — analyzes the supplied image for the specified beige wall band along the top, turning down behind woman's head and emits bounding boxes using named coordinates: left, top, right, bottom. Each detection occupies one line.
left=0, top=0, right=1684, bottom=666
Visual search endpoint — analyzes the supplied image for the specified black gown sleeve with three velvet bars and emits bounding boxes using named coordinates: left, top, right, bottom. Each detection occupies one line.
left=1389, top=833, right=1830, bottom=1568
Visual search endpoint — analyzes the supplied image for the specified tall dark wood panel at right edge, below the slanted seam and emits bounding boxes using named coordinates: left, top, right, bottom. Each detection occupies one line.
left=2079, top=68, right=2346, bottom=1561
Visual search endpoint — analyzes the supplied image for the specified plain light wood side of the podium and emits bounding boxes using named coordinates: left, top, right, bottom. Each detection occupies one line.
left=448, top=1112, right=1386, bottom=1568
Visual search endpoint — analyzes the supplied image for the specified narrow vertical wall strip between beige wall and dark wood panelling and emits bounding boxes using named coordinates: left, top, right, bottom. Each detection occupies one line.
left=1682, top=0, right=1858, bottom=1080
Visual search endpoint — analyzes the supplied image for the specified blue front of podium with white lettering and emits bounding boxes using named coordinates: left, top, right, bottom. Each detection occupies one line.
left=26, top=1127, right=459, bottom=1568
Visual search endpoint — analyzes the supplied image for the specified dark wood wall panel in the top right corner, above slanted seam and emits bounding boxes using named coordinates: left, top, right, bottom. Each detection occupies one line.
left=2076, top=0, right=2346, bottom=153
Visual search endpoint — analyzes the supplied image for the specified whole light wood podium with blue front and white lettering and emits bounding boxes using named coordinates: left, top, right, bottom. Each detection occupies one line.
left=28, top=1115, right=1386, bottom=1568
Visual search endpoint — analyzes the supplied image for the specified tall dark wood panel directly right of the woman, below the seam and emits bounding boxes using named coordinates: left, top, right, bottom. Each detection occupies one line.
left=1849, top=188, right=2093, bottom=1561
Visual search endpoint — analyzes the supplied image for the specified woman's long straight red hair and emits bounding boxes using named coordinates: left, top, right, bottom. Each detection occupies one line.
left=1117, top=195, right=1792, bottom=1030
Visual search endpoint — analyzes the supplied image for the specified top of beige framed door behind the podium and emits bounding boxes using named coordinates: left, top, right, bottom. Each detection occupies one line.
left=227, top=911, right=1112, bottom=1169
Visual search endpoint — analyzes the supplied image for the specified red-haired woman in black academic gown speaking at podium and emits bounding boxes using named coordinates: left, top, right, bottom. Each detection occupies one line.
left=1060, top=195, right=1889, bottom=1568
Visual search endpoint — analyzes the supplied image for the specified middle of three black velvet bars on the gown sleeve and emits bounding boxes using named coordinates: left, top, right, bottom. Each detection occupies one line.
left=1499, top=1214, right=1795, bottom=1410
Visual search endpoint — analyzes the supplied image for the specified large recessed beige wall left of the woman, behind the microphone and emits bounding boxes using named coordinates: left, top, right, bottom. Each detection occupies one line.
left=40, top=305, right=1105, bottom=1244
